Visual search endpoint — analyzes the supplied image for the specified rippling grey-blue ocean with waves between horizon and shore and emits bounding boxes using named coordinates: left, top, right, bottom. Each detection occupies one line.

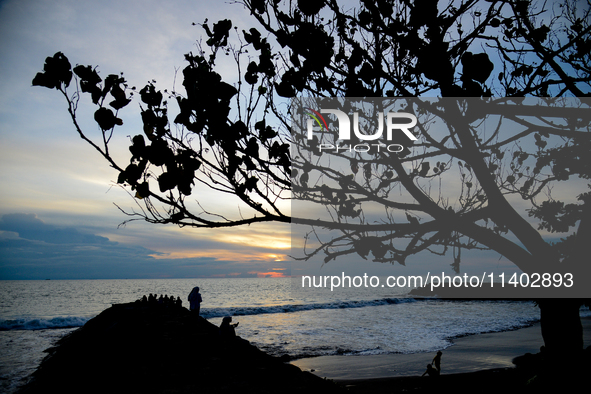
left=0, top=278, right=590, bottom=393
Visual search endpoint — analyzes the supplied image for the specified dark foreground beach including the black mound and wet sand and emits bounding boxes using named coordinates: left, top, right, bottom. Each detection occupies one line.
left=22, top=301, right=591, bottom=394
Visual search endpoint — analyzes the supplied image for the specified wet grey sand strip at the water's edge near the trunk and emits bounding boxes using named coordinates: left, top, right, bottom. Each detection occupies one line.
left=292, top=318, right=591, bottom=383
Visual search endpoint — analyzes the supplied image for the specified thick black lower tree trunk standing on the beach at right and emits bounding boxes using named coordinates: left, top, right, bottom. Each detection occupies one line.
left=538, top=299, right=583, bottom=356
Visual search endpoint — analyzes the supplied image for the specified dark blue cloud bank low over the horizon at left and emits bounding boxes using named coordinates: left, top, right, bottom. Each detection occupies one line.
left=0, top=213, right=289, bottom=280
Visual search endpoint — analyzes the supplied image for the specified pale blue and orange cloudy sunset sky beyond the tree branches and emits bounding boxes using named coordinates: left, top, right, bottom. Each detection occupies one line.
left=0, top=0, right=584, bottom=280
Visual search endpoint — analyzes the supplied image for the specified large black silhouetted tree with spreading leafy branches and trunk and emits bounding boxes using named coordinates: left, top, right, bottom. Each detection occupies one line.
left=33, top=0, right=591, bottom=351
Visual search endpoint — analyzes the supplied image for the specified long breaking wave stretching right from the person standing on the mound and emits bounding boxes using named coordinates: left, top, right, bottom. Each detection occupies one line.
left=201, top=298, right=416, bottom=319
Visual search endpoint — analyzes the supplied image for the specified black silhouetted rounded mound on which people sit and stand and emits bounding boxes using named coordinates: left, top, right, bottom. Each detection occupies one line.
left=21, top=303, right=341, bottom=394
